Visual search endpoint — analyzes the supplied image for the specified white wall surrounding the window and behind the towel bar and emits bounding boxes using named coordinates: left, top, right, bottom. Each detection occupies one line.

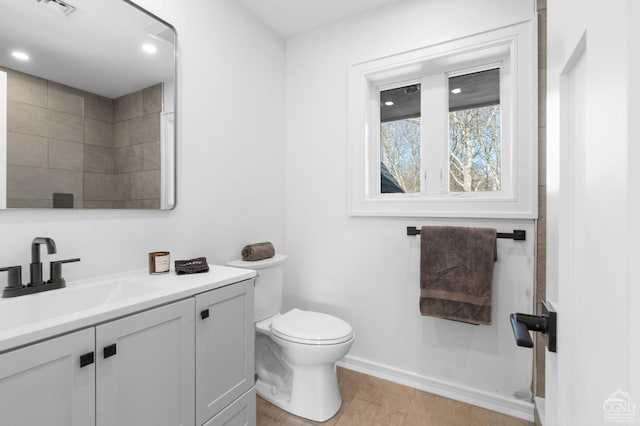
left=285, top=0, right=536, bottom=418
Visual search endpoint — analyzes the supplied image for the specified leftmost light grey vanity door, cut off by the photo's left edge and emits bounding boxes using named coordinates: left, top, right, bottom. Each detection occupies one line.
left=0, top=328, right=95, bottom=426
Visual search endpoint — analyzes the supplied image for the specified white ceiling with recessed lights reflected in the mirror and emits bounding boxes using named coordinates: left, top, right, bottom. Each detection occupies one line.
left=0, top=0, right=175, bottom=98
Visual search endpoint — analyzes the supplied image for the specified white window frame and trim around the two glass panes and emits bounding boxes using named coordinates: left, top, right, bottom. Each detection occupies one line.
left=348, top=20, right=538, bottom=219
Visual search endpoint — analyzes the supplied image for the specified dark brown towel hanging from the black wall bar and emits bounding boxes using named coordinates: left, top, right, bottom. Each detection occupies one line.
left=420, top=226, right=497, bottom=325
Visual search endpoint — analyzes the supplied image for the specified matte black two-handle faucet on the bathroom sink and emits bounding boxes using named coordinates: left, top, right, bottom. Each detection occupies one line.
left=0, top=237, right=80, bottom=297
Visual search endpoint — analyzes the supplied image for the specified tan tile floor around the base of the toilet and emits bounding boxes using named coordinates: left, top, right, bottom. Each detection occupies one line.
left=257, top=367, right=533, bottom=426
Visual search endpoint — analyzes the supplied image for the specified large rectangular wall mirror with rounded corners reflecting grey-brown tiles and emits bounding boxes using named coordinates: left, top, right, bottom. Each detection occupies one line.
left=0, top=0, right=176, bottom=209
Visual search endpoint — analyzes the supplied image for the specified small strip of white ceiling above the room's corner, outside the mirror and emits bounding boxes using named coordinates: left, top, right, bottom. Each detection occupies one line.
left=240, top=0, right=407, bottom=38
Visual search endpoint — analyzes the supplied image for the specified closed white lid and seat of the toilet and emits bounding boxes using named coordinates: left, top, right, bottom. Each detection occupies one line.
left=271, top=309, right=353, bottom=345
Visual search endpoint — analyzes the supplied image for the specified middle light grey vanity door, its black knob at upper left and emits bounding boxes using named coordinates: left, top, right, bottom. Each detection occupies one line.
left=96, top=298, right=195, bottom=426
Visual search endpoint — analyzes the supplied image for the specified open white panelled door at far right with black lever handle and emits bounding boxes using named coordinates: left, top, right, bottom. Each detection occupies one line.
left=544, top=0, right=640, bottom=426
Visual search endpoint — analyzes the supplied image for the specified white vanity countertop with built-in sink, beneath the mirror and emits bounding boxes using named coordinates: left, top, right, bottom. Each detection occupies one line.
left=0, top=265, right=256, bottom=353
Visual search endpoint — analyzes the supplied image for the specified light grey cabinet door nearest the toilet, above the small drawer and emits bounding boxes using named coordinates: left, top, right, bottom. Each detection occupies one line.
left=196, top=280, right=255, bottom=425
